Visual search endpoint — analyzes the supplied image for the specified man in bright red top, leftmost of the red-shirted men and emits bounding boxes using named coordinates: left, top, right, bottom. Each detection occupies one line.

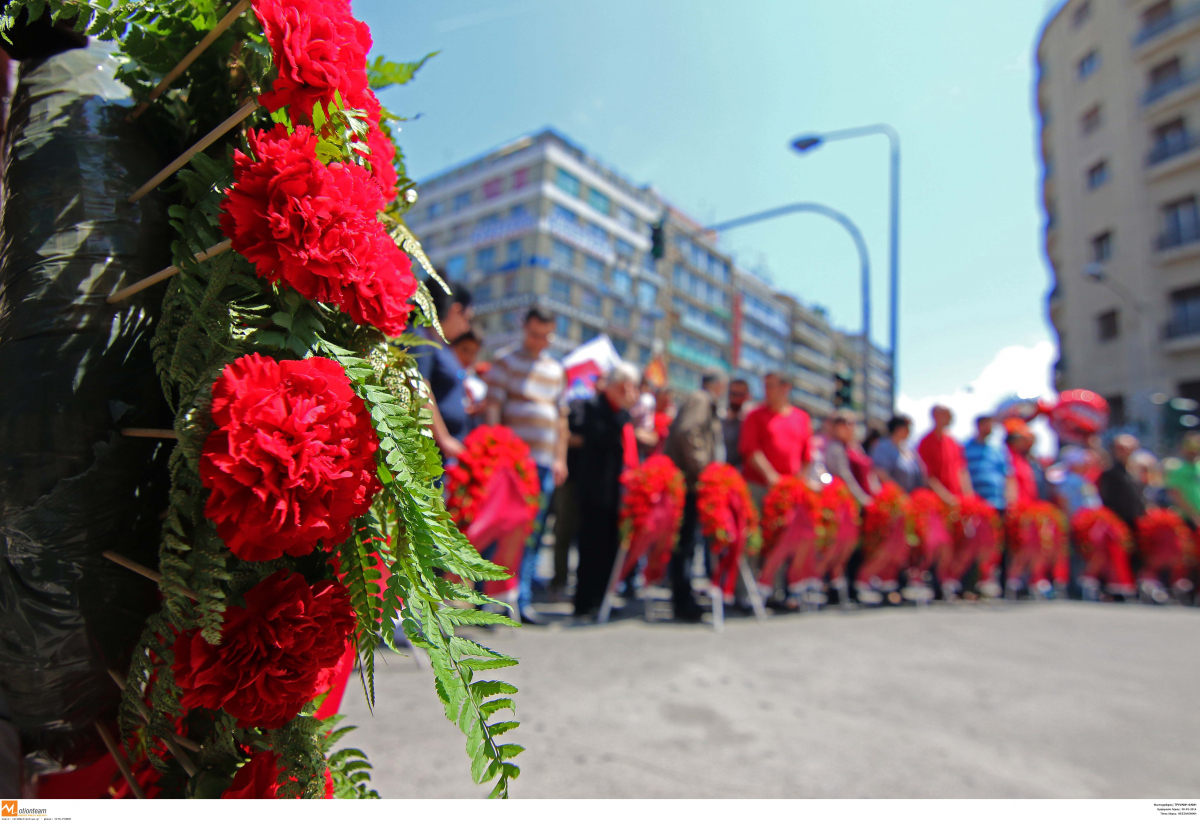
left=738, top=372, right=812, bottom=502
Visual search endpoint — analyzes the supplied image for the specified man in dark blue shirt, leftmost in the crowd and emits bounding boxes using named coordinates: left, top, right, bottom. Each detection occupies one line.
left=413, top=281, right=472, bottom=460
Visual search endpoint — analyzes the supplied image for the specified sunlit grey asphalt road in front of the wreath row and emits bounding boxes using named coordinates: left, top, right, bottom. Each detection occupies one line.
left=342, top=603, right=1200, bottom=798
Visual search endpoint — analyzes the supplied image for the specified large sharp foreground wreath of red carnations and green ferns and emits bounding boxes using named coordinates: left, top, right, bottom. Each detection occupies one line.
left=18, top=0, right=523, bottom=798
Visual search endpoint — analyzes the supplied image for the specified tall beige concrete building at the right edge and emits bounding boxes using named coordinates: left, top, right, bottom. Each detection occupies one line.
left=1037, top=0, right=1200, bottom=432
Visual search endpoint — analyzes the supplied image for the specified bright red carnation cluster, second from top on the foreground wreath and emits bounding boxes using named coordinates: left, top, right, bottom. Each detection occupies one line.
left=221, top=125, right=416, bottom=336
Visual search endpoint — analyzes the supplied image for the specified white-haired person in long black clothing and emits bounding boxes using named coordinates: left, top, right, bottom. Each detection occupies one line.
left=575, top=362, right=637, bottom=616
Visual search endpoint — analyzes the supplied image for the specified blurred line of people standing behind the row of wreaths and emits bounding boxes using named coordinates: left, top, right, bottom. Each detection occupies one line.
left=414, top=283, right=1200, bottom=624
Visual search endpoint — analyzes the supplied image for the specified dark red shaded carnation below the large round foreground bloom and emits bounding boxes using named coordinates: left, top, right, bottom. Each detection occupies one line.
left=172, top=570, right=354, bottom=727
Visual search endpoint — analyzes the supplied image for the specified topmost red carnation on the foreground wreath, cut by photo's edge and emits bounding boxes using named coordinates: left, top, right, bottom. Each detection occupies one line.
left=254, top=0, right=379, bottom=122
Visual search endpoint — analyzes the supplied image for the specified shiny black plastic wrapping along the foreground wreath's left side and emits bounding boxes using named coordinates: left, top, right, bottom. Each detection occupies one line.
left=0, top=42, right=174, bottom=777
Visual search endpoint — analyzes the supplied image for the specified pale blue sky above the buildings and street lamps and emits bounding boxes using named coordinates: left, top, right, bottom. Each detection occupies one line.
left=354, top=0, right=1049, bottom=410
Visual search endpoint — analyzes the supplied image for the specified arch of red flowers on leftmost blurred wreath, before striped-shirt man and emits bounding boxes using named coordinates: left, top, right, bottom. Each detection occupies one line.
left=446, top=425, right=541, bottom=527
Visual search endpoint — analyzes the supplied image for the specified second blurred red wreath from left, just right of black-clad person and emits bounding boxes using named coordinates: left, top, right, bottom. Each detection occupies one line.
left=620, top=455, right=685, bottom=585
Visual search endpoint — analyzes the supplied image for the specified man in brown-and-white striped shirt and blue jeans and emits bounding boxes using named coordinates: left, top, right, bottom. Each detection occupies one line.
left=487, top=307, right=570, bottom=624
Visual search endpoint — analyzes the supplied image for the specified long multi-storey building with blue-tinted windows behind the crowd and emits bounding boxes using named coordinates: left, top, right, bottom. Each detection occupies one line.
left=409, top=130, right=892, bottom=418
